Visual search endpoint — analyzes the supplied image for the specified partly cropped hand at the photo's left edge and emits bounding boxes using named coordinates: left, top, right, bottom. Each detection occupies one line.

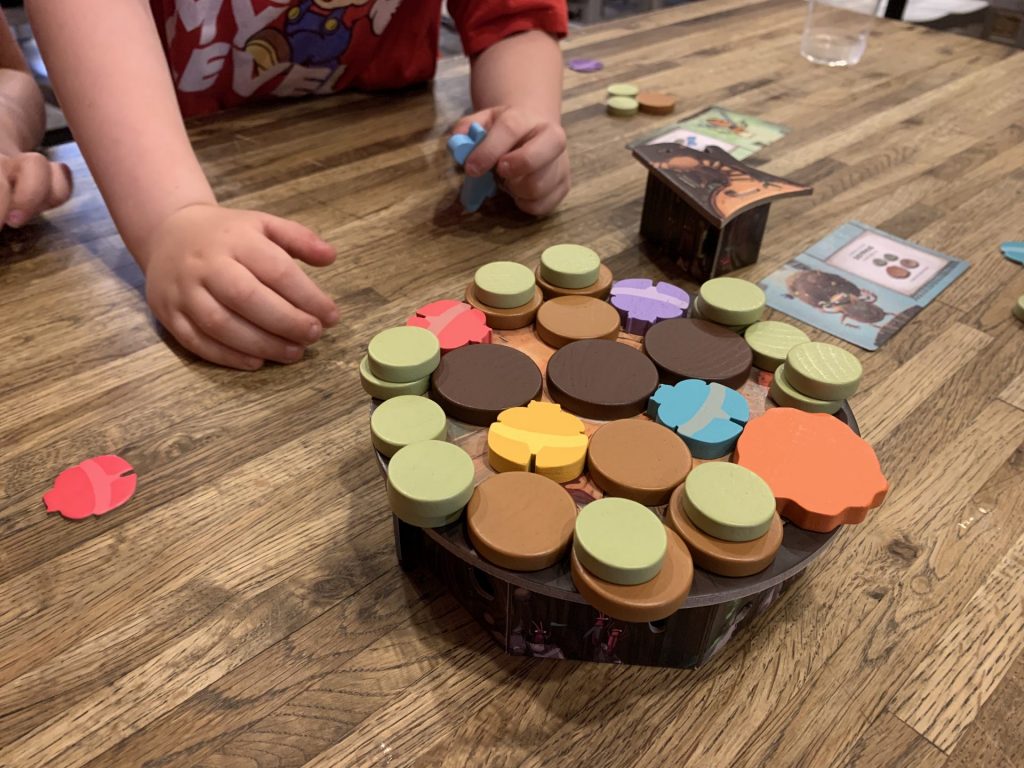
left=0, top=152, right=71, bottom=227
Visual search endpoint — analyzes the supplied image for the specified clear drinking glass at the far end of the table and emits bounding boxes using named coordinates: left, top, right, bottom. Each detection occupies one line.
left=800, top=0, right=884, bottom=67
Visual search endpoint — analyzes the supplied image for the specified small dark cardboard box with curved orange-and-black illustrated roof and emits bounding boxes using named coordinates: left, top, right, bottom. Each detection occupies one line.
left=633, top=143, right=812, bottom=283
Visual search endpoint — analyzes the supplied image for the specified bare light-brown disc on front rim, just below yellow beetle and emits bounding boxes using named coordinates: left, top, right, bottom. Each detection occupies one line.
left=466, top=472, right=577, bottom=570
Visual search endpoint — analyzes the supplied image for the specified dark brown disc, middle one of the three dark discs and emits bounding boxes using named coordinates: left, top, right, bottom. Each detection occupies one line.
left=548, top=339, right=659, bottom=421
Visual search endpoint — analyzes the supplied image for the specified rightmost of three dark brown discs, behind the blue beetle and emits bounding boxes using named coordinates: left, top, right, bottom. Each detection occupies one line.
left=643, top=317, right=754, bottom=389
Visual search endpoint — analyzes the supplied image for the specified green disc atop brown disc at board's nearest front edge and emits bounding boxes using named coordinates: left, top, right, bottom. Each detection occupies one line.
left=572, top=498, right=669, bottom=586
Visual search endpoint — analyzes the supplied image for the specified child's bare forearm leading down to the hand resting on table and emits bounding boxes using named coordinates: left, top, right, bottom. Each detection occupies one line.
left=26, top=0, right=215, bottom=262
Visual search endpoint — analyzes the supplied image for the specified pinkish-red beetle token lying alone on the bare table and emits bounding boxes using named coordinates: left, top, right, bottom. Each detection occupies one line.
left=43, top=455, right=138, bottom=520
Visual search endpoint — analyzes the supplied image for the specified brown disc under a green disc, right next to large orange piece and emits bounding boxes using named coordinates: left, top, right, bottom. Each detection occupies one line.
left=665, top=485, right=782, bottom=578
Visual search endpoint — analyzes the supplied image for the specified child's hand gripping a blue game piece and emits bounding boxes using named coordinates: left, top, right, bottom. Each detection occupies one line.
left=454, top=106, right=569, bottom=216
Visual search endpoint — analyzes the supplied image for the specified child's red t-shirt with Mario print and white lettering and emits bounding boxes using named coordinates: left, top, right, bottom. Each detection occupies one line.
left=151, top=0, right=568, bottom=116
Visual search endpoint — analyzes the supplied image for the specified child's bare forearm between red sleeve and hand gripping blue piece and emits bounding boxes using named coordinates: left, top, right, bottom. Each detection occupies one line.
left=471, top=31, right=562, bottom=122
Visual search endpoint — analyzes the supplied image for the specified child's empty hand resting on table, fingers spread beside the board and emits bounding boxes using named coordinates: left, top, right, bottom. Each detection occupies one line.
left=138, top=205, right=338, bottom=370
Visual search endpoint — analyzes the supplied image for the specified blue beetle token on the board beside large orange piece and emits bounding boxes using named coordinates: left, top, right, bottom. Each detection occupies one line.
left=647, top=379, right=751, bottom=459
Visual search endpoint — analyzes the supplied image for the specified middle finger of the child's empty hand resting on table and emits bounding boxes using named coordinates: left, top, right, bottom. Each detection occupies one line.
left=204, top=260, right=324, bottom=347
